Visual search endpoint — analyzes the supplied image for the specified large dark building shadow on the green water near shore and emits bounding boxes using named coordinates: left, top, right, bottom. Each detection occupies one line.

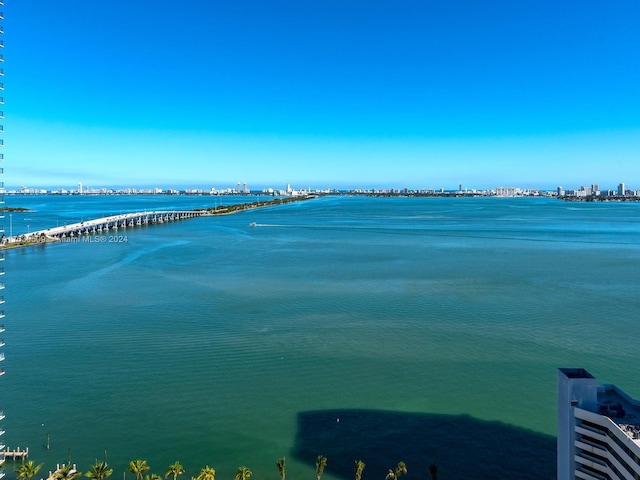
left=293, top=410, right=556, bottom=480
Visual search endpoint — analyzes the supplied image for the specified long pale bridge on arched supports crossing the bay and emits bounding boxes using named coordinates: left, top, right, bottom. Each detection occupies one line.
left=6, top=210, right=207, bottom=243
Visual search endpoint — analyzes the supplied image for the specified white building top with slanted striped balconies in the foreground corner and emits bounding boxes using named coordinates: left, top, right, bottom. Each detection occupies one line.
left=557, top=368, right=640, bottom=480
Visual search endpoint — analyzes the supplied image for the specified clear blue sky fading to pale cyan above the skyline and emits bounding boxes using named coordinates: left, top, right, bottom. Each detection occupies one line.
left=2, top=0, right=640, bottom=189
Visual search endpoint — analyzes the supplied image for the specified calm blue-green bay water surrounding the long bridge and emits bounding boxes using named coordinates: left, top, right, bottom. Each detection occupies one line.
left=0, top=196, right=640, bottom=480
